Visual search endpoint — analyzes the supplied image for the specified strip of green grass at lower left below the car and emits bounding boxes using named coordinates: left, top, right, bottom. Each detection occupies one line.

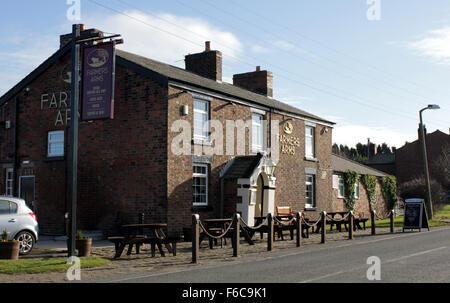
left=0, top=257, right=110, bottom=274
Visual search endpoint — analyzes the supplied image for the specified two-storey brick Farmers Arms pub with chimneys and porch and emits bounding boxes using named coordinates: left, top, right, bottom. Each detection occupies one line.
left=0, top=28, right=334, bottom=235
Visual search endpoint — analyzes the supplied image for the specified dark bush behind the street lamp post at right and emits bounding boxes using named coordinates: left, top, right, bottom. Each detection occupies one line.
left=398, top=177, right=446, bottom=211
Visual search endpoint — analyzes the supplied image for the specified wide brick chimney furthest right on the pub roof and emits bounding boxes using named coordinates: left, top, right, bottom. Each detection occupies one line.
left=233, top=66, right=273, bottom=98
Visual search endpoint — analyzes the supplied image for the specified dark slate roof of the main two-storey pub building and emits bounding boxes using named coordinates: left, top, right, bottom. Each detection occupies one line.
left=0, top=44, right=335, bottom=125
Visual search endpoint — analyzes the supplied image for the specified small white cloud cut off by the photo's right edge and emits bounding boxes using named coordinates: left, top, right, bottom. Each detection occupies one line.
left=407, top=26, right=450, bottom=64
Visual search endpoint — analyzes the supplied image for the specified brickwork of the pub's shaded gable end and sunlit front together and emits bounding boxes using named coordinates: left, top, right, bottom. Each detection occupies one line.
left=0, top=28, right=334, bottom=234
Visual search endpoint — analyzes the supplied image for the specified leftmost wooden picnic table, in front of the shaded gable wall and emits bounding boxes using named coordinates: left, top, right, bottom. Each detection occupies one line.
left=108, top=223, right=178, bottom=259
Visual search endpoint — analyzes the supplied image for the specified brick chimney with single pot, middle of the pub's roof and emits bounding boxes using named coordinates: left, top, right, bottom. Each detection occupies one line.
left=184, top=41, right=222, bottom=81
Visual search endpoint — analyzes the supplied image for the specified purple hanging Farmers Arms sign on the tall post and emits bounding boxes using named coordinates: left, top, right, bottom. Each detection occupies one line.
left=81, top=42, right=116, bottom=121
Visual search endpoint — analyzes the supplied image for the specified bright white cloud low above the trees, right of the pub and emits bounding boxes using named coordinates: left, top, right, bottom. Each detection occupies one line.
left=333, top=125, right=417, bottom=147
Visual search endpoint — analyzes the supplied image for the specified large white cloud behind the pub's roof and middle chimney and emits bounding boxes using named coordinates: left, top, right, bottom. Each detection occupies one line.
left=83, top=11, right=242, bottom=67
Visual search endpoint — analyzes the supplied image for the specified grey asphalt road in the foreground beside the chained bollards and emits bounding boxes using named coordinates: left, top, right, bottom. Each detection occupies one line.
left=84, top=227, right=450, bottom=283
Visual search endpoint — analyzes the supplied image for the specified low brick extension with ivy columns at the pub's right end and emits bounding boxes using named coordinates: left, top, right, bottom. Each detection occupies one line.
left=329, top=154, right=389, bottom=218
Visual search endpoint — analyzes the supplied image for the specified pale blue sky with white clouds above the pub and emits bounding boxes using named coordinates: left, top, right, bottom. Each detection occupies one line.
left=0, top=0, right=450, bottom=148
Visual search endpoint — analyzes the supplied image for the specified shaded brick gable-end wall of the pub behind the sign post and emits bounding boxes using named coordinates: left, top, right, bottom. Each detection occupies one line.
left=0, top=51, right=167, bottom=234
